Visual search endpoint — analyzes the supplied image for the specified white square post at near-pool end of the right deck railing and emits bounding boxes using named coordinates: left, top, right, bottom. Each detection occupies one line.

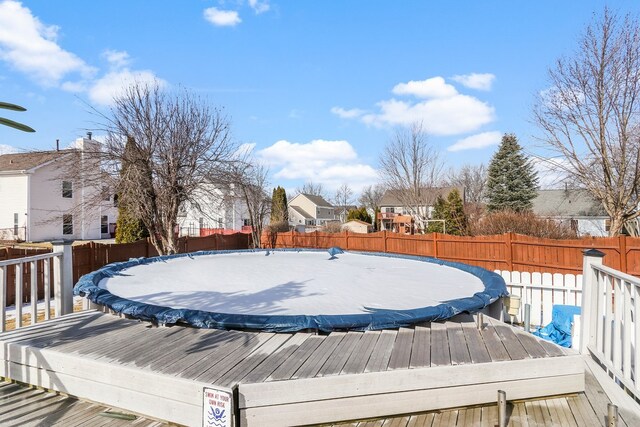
left=580, top=249, right=604, bottom=354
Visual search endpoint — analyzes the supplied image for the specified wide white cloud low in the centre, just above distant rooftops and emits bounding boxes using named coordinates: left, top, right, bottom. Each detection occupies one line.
left=257, top=139, right=377, bottom=191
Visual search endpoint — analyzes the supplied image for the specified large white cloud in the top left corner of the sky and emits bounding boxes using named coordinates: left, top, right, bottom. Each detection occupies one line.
left=0, top=0, right=96, bottom=86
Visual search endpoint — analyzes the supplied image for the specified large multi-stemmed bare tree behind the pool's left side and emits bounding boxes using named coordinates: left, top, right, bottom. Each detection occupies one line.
left=87, top=83, right=236, bottom=254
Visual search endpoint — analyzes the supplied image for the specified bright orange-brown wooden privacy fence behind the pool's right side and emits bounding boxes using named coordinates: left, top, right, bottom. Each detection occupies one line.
left=261, top=231, right=640, bottom=276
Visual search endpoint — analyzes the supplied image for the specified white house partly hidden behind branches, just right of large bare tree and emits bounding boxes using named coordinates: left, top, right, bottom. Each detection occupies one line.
left=178, top=186, right=251, bottom=236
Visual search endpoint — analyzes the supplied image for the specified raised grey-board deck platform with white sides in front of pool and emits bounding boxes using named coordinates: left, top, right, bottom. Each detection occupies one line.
left=0, top=312, right=584, bottom=426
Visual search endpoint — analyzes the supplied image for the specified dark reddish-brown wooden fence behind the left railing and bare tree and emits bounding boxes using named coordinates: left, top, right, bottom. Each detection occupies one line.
left=0, top=233, right=251, bottom=306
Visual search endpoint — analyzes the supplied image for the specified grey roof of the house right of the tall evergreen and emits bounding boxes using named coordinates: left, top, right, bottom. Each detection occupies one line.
left=533, top=189, right=607, bottom=217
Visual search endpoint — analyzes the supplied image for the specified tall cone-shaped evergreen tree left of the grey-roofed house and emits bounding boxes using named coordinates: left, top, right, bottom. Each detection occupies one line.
left=487, top=134, right=538, bottom=212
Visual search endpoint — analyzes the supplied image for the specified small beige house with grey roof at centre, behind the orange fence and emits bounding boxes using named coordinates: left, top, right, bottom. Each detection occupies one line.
left=289, top=193, right=336, bottom=231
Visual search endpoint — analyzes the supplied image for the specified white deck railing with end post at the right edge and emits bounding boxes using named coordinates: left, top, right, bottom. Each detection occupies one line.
left=580, top=251, right=640, bottom=398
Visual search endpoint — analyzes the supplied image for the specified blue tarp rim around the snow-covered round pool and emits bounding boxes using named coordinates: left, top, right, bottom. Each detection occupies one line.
left=74, top=248, right=508, bottom=332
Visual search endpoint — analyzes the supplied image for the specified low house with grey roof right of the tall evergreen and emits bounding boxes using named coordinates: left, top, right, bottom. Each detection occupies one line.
left=533, top=189, right=610, bottom=237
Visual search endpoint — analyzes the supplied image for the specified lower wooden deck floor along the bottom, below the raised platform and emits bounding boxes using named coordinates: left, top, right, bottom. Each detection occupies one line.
left=0, top=362, right=640, bottom=427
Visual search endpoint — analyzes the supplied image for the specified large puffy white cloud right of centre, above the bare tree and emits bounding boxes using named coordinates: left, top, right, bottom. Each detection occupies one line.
left=362, top=94, right=495, bottom=135
